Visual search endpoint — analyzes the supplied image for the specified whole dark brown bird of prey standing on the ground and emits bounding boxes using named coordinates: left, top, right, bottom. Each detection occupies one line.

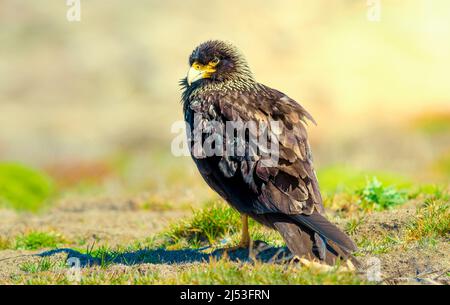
left=180, top=40, right=357, bottom=265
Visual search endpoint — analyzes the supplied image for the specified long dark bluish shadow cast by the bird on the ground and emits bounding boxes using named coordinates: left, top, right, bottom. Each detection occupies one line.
left=38, top=241, right=292, bottom=267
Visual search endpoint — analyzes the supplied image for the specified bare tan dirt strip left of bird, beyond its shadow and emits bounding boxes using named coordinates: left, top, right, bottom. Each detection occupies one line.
left=0, top=198, right=188, bottom=246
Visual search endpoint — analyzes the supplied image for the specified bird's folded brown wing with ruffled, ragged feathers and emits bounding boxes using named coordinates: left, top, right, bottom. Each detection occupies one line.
left=211, top=87, right=323, bottom=215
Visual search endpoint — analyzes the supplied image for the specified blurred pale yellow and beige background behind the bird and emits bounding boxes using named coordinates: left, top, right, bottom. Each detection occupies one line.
left=0, top=0, right=450, bottom=211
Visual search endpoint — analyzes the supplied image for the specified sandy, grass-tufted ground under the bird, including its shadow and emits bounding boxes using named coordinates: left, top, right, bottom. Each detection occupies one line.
left=0, top=176, right=450, bottom=284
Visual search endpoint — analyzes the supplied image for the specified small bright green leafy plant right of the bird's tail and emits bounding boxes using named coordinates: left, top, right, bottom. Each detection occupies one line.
left=356, top=177, right=407, bottom=211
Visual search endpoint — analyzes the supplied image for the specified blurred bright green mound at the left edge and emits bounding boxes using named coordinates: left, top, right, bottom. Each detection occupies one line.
left=0, top=163, right=54, bottom=212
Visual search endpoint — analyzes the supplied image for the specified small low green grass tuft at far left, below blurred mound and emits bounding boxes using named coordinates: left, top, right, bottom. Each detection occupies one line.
left=15, top=231, right=67, bottom=250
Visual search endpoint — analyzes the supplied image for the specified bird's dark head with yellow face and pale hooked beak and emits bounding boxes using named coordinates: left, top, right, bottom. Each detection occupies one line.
left=186, top=40, right=253, bottom=86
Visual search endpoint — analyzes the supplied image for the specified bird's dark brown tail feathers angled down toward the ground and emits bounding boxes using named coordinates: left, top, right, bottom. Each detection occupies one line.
left=272, top=212, right=360, bottom=267
